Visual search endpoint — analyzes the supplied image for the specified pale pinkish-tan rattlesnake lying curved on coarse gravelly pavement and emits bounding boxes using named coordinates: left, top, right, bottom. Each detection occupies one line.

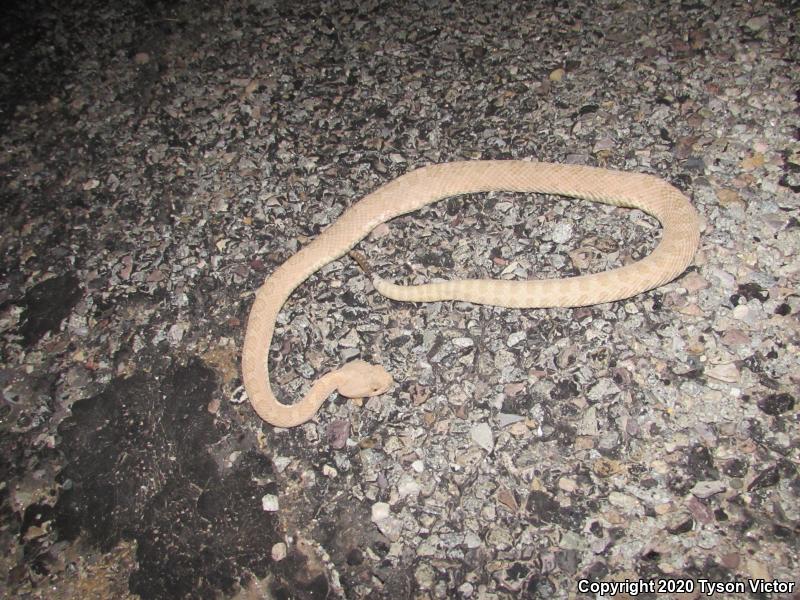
left=242, top=160, right=700, bottom=427
